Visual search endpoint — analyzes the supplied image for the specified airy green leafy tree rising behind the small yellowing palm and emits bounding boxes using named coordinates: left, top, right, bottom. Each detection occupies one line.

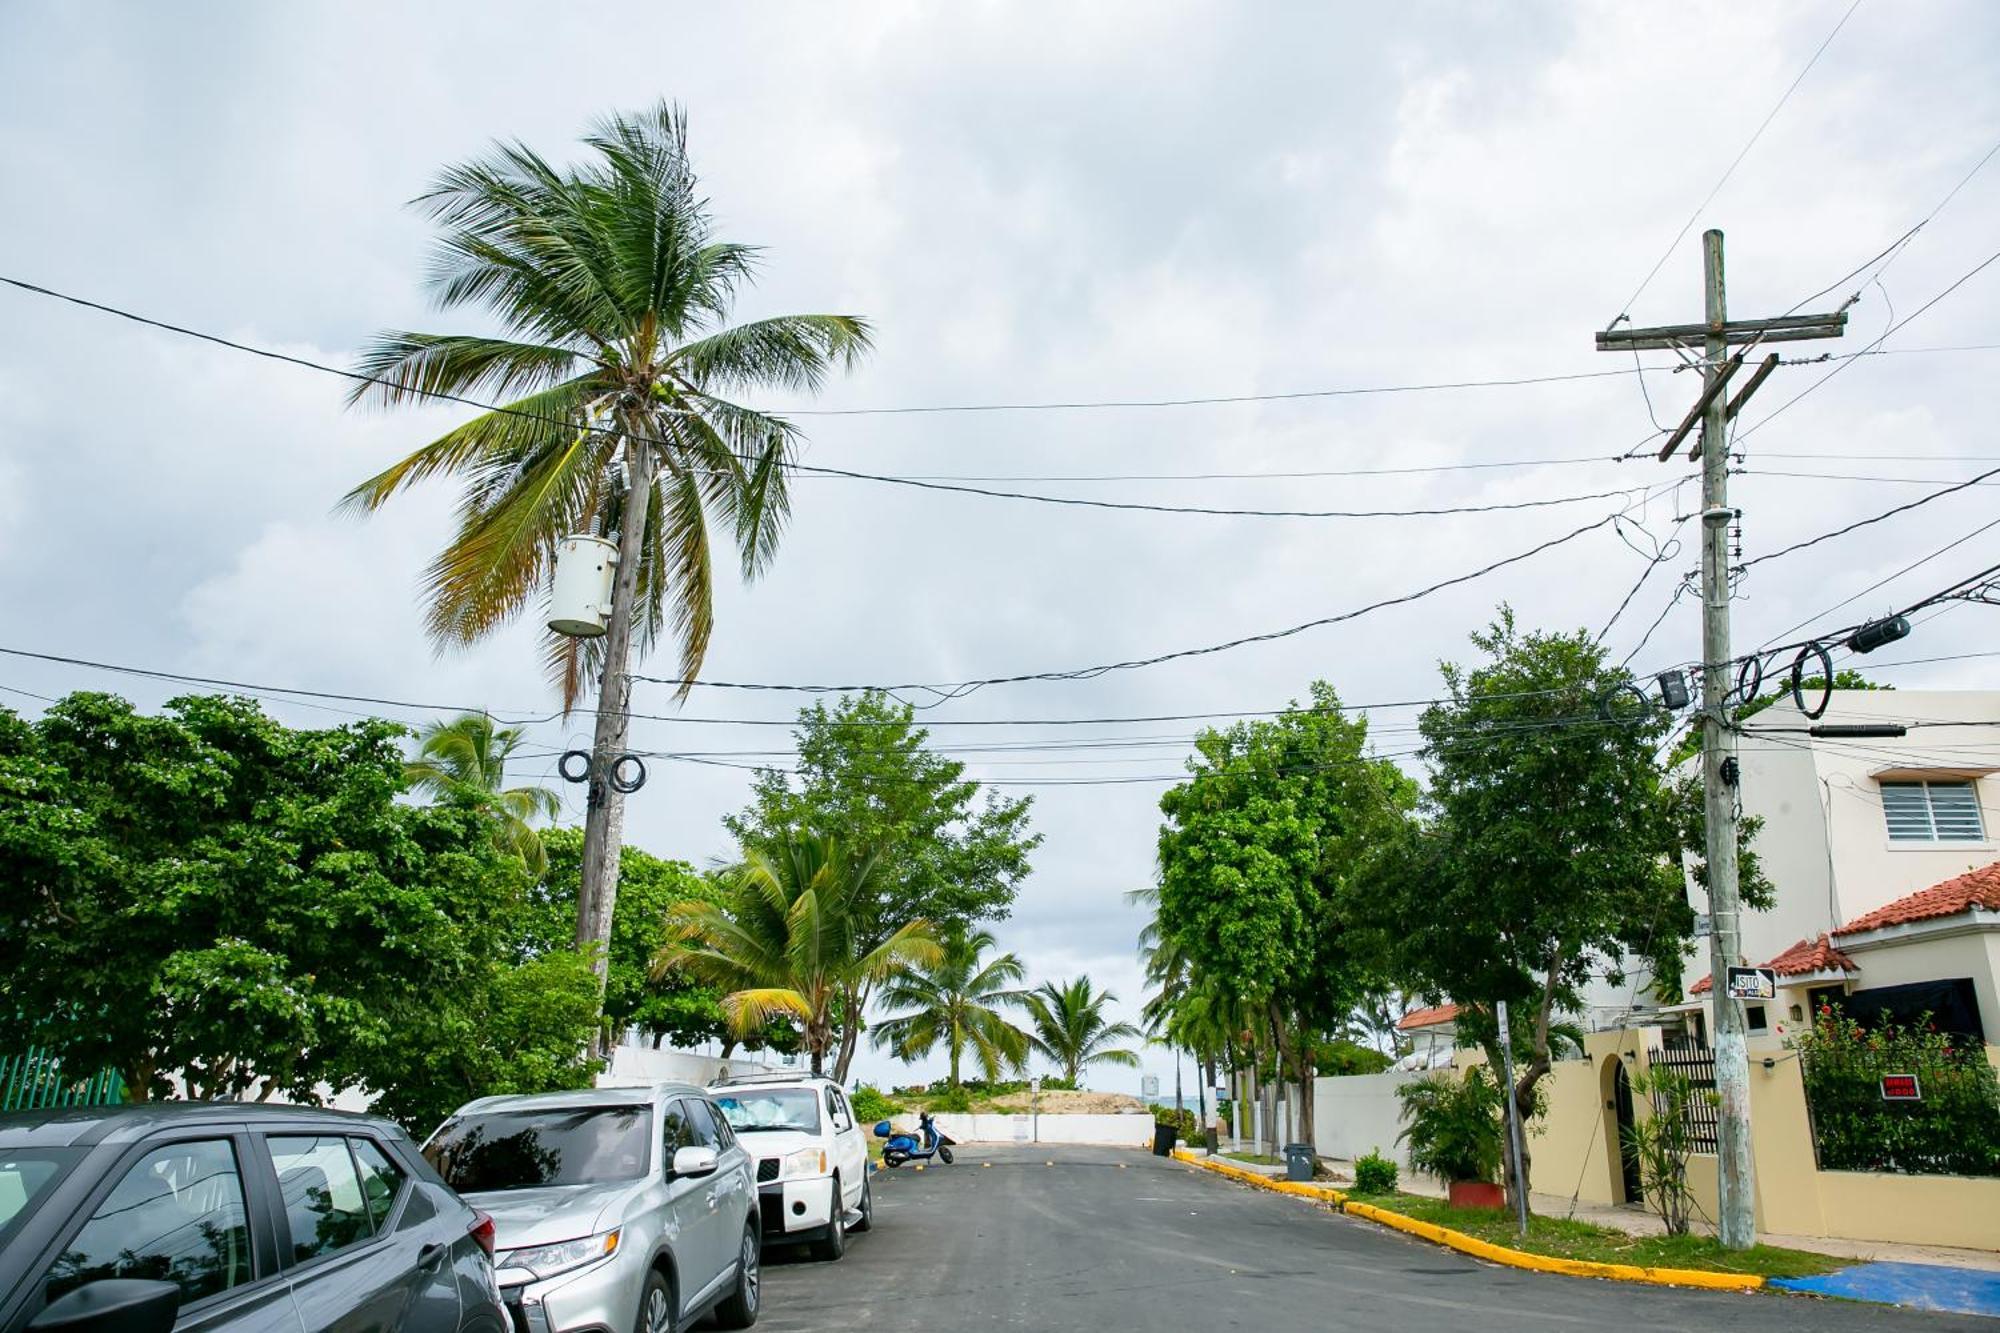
left=722, top=691, right=1042, bottom=1079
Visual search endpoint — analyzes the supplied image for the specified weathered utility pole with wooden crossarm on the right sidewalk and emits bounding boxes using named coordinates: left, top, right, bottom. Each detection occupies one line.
left=1598, top=230, right=1848, bottom=1249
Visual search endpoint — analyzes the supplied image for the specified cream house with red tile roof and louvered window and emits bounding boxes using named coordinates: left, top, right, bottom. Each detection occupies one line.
left=1660, top=691, right=2000, bottom=1049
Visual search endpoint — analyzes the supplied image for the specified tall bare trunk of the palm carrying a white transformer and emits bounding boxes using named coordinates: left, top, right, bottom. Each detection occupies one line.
left=576, top=428, right=656, bottom=1040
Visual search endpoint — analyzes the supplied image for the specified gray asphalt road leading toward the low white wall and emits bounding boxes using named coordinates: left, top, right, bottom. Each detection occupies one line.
left=758, top=1147, right=1994, bottom=1333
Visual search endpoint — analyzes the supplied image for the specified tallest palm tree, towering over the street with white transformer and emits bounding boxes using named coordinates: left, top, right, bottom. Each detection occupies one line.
left=344, top=104, right=868, bottom=987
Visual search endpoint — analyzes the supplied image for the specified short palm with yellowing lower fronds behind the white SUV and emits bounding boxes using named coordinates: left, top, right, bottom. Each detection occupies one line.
left=652, top=837, right=942, bottom=1073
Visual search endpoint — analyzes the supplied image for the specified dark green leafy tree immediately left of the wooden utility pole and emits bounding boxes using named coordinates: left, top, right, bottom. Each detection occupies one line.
left=1366, top=606, right=1692, bottom=1200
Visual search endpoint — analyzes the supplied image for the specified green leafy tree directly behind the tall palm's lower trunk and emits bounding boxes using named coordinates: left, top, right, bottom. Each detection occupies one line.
left=522, top=829, right=728, bottom=1047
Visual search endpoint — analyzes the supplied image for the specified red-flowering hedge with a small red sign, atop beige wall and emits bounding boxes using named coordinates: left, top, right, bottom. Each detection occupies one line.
left=1792, top=1005, right=2000, bottom=1175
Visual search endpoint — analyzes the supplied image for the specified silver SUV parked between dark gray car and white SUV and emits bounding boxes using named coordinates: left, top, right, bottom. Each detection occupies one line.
left=424, top=1083, right=760, bottom=1333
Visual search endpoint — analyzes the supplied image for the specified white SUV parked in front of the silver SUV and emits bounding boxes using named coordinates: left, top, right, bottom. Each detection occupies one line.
left=708, top=1075, right=874, bottom=1259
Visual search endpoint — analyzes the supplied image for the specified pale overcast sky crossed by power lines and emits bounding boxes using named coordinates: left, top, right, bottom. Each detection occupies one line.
left=0, top=0, right=2000, bottom=1093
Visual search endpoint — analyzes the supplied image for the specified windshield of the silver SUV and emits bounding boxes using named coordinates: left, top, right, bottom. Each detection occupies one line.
left=424, top=1105, right=652, bottom=1195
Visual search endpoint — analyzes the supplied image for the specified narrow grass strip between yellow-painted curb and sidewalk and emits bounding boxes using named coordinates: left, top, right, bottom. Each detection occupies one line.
left=1368, top=1193, right=1854, bottom=1277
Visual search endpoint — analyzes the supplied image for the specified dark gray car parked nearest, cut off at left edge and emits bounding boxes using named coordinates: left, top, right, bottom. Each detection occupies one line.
left=0, top=1103, right=506, bottom=1333
